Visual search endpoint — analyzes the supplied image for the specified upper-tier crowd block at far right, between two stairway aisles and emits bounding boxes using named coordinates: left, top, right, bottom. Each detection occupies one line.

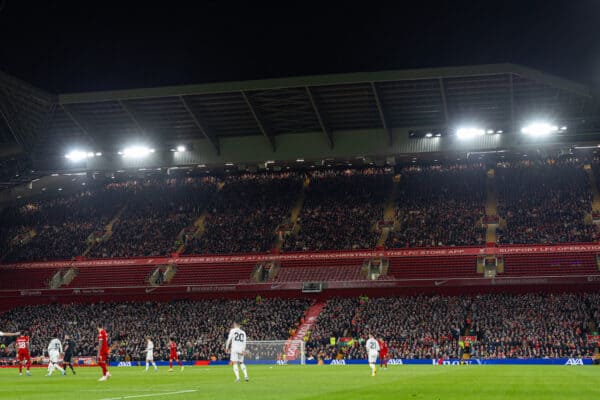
left=495, top=160, right=598, bottom=244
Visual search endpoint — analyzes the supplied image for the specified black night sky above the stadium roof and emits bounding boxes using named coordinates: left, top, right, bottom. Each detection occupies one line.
left=0, top=0, right=600, bottom=92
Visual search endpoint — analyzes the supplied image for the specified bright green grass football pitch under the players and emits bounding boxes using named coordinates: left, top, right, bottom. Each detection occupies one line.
left=0, top=365, right=600, bottom=400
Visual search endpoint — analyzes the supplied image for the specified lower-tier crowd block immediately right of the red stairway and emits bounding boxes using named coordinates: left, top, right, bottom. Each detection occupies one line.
left=309, top=296, right=468, bottom=359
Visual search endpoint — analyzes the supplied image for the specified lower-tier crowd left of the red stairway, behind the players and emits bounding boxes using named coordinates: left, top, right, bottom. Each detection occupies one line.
left=0, top=298, right=310, bottom=361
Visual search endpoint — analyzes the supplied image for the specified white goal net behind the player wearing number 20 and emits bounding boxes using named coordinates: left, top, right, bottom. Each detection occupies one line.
left=245, top=340, right=306, bottom=364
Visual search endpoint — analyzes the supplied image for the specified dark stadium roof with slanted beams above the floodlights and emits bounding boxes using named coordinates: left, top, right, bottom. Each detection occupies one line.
left=0, top=64, right=598, bottom=158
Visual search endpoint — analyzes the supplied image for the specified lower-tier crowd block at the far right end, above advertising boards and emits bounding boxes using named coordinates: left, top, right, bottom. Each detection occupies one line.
left=471, top=294, right=600, bottom=358
